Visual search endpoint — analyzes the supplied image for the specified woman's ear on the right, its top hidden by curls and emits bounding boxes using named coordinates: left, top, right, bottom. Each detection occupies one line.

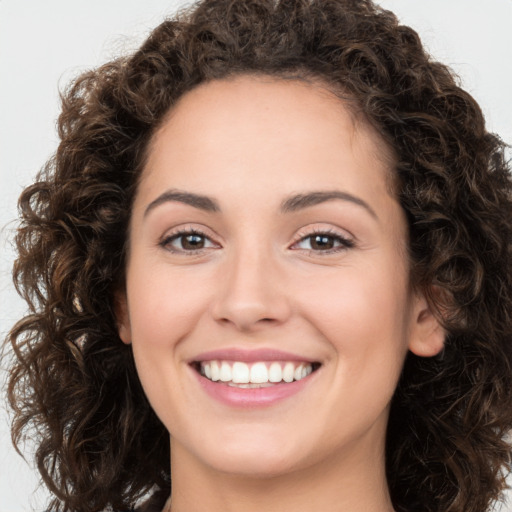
left=409, top=294, right=446, bottom=357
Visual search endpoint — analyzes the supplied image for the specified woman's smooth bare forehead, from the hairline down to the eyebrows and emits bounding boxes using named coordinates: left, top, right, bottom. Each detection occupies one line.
left=132, top=73, right=407, bottom=260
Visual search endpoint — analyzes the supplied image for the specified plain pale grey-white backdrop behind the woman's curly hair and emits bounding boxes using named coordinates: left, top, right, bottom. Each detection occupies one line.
left=0, top=0, right=512, bottom=512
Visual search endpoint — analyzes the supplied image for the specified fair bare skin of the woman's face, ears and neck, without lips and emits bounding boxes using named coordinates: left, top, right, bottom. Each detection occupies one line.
left=118, top=76, right=443, bottom=512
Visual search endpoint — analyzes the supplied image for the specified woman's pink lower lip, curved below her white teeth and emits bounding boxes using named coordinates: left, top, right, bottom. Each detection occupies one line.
left=192, top=370, right=316, bottom=408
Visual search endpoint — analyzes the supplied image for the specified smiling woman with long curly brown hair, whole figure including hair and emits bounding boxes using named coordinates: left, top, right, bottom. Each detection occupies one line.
left=5, top=0, right=512, bottom=512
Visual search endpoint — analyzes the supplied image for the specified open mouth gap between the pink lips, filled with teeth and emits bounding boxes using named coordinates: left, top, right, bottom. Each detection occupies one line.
left=191, top=360, right=320, bottom=389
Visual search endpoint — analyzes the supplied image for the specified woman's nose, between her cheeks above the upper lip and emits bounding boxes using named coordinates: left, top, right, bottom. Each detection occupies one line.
left=213, top=245, right=291, bottom=332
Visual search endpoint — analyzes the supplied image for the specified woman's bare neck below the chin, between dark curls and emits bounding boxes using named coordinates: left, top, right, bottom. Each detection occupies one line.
left=164, top=436, right=393, bottom=512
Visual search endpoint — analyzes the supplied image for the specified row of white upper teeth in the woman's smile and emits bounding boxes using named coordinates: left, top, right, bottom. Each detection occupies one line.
left=201, top=361, right=313, bottom=384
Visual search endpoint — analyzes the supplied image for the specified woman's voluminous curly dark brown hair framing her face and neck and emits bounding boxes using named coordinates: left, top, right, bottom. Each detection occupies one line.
left=8, top=0, right=512, bottom=512
